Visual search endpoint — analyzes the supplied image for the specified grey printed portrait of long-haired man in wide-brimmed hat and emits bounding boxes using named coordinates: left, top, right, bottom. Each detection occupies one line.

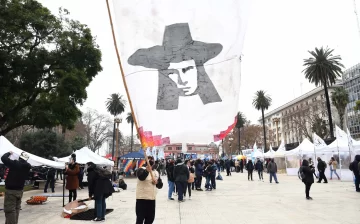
left=128, top=23, right=223, bottom=110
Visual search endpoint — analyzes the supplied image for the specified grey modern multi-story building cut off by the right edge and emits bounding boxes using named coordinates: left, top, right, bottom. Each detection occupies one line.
left=343, top=63, right=360, bottom=139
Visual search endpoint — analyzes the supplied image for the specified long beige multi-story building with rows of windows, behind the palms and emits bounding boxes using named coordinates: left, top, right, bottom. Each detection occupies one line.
left=259, top=81, right=341, bottom=147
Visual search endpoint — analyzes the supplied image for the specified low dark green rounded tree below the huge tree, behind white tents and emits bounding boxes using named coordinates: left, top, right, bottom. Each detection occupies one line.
left=20, top=130, right=71, bottom=158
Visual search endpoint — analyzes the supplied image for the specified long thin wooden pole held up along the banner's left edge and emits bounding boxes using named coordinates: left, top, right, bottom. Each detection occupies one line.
left=106, top=0, right=155, bottom=181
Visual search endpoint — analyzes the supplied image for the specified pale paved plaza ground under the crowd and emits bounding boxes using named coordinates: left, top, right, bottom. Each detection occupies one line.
left=0, top=173, right=360, bottom=224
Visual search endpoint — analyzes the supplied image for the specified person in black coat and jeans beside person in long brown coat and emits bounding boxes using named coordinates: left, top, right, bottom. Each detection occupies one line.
left=87, top=162, right=114, bottom=222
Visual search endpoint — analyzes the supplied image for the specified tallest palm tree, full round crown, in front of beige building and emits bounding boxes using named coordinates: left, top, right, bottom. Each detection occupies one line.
left=303, top=47, right=344, bottom=139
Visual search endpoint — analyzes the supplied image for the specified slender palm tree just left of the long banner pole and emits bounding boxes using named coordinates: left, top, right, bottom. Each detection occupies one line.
left=106, top=93, right=126, bottom=158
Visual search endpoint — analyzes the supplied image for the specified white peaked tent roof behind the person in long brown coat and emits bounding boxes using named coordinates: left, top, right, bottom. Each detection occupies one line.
left=54, top=147, right=114, bottom=166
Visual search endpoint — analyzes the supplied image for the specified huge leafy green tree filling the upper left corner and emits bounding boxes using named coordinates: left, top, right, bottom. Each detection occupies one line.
left=0, top=0, right=102, bottom=135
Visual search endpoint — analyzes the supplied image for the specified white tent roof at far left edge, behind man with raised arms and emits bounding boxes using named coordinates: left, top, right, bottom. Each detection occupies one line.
left=0, top=136, right=65, bottom=169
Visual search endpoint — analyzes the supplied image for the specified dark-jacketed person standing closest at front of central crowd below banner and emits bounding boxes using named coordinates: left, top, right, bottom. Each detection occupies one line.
left=174, top=159, right=190, bottom=202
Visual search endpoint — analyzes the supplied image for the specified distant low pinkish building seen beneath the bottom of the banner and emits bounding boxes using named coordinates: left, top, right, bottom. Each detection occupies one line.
left=164, top=143, right=219, bottom=158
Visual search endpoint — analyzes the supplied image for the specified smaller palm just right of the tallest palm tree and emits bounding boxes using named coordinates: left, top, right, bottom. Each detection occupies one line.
left=331, top=87, right=349, bottom=130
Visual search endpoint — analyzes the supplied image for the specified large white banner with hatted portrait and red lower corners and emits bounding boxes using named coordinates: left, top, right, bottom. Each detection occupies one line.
left=113, top=0, right=250, bottom=146
